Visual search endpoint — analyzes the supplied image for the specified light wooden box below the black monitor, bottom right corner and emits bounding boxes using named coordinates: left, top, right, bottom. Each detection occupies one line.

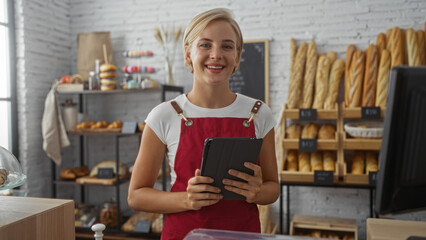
left=367, top=218, right=426, bottom=240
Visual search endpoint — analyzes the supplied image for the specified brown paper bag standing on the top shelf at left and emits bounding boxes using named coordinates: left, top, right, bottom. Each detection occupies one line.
left=77, top=32, right=114, bottom=81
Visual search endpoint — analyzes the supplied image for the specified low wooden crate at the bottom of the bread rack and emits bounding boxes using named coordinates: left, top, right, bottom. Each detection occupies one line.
left=290, top=215, right=358, bottom=239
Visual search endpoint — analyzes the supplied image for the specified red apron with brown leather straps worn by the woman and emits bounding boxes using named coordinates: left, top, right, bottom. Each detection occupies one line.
left=161, top=100, right=260, bottom=240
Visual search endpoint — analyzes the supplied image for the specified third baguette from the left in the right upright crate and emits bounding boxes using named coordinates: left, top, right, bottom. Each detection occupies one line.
left=362, top=44, right=379, bottom=107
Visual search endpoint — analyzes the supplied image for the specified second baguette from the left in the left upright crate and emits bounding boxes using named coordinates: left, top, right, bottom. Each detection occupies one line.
left=300, top=40, right=318, bottom=108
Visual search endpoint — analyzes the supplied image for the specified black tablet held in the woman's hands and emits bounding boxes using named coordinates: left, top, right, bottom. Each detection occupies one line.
left=201, top=137, right=263, bottom=200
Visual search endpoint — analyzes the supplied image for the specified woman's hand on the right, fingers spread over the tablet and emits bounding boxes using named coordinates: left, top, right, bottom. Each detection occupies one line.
left=222, top=162, right=263, bottom=203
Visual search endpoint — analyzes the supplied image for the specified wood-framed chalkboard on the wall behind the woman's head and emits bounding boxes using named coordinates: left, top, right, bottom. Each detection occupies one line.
left=229, top=39, right=269, bottom=104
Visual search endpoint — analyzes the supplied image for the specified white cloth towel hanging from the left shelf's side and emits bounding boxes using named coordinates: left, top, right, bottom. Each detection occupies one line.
left=41, top=81, right=70, bottom=165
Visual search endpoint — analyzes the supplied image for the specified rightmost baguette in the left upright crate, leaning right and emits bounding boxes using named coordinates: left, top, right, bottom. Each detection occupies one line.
left=324, top=59, right=345, bottom=109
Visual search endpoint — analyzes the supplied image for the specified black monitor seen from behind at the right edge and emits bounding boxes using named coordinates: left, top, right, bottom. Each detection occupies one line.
left=375, top=67, right=426, bottom=214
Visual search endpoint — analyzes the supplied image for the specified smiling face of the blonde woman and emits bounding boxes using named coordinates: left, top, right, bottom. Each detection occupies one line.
left=186, top=21, right=239, bottom=85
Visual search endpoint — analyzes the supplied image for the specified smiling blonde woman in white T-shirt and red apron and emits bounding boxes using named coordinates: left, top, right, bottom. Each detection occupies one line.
left=128, top=9, right=280, bottom=239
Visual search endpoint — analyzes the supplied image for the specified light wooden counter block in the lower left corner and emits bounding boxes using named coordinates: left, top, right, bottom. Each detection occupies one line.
left=0, top=196, right=75, bottom=240
